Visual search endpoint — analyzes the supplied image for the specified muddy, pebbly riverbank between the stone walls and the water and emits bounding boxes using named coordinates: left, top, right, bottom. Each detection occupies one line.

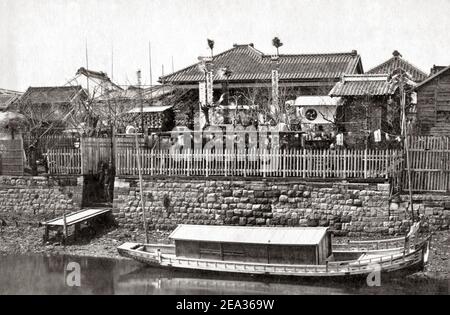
left=0, top=217, right=450, bottom=279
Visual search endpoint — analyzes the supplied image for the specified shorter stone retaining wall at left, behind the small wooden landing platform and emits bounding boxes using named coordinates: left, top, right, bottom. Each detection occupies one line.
left=0, top=176, right=83, bottom=216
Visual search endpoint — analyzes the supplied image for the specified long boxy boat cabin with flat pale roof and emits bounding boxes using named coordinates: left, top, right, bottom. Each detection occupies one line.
left=169, top=224, right=332, bottom=265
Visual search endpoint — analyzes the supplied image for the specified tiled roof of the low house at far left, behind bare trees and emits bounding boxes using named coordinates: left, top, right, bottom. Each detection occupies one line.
left=21, top=85, right=86, bottom=104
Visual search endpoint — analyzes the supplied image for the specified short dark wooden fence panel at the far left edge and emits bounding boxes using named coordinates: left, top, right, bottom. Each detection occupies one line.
left=0, top=139, right=24, bottom=175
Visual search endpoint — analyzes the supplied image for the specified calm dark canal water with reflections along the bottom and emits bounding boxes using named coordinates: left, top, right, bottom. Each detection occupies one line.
left=0, top=255, right=448, bottom=295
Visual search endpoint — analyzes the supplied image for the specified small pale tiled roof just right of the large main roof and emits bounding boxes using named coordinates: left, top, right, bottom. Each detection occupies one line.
left=329, top=74, right=395, bottom=96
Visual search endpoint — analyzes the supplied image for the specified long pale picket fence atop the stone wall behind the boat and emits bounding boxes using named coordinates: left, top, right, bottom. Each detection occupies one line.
left=116, top=147, right=401, bottom=178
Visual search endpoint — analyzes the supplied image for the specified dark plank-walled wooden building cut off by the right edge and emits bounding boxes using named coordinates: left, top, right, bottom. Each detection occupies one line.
left=415, top=66, right=450, bottom=136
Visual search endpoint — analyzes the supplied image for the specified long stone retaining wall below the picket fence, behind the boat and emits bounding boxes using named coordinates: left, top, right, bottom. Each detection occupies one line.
left=113, top=178, right=422, bottom=236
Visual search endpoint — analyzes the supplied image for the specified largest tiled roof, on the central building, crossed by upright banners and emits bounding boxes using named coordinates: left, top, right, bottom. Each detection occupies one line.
left=160, top=44, right=362, bottom=83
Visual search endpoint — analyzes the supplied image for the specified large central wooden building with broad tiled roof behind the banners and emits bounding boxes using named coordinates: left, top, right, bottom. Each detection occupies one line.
left=159, top=44, right=363, bottom=129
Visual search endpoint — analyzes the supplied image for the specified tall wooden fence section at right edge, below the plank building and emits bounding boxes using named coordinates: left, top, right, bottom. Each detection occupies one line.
left=402, top=136, right=450, bottom=192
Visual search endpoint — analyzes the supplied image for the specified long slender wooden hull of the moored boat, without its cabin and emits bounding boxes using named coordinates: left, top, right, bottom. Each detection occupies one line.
left=118, top=239, right=429, bottom=279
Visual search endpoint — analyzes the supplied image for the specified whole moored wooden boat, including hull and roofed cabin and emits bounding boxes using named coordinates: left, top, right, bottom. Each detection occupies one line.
left=118, top=224, right=430, bottom=278
